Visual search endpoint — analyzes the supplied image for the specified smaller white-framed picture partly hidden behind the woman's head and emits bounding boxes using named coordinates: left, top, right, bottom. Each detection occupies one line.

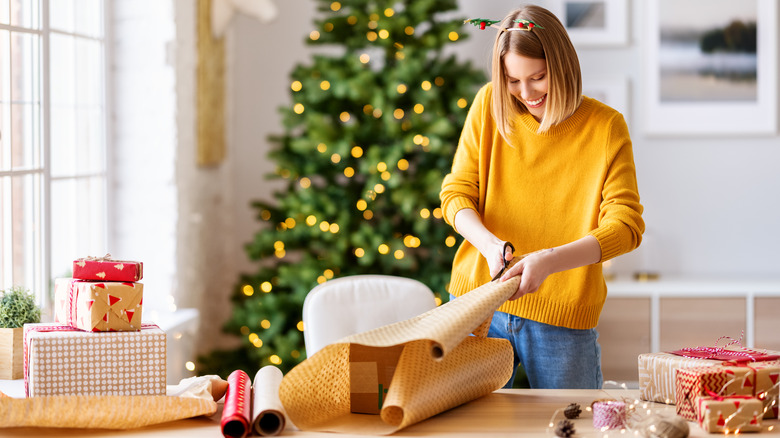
left=550, top=0, right=629, bottom=47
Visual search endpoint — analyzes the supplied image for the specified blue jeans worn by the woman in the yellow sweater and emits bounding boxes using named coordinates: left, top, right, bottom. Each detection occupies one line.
left=488, top=312, right=603, bottom=389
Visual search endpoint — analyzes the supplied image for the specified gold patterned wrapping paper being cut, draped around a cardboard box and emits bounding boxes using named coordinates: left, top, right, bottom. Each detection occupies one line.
left=279, top=277, right=520, bottom=435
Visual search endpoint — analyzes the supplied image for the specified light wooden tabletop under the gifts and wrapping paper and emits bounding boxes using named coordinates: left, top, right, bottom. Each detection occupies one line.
left=0, top=381, right=780, bottom=438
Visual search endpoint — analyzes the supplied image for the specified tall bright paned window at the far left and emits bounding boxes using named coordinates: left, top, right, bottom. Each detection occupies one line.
left=0, top=0, right=107, bottom=306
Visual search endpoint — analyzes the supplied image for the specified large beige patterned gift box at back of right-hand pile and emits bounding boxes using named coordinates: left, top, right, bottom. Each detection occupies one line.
left=638, top=351, right=780, bottom=406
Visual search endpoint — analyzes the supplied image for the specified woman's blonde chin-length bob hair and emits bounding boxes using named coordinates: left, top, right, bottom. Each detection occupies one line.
left=492, top=5, right=582, bottom=135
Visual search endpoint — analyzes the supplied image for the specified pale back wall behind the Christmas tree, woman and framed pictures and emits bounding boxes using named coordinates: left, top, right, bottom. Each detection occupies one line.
left=228, top=0, right=780, bottom=276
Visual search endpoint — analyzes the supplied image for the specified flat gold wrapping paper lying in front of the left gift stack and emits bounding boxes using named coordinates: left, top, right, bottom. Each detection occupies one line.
left=0, top=393, right=217, bottom=429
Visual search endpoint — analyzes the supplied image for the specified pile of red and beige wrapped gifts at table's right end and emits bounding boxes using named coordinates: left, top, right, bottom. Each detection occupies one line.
left=639, top=348, right=780, bottom=434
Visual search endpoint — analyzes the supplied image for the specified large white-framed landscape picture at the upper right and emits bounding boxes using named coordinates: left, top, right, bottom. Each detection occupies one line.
left=642, top=0, right=778, bottom=135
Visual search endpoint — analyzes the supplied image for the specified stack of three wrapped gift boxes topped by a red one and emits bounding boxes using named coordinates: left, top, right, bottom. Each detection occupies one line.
left=24, top=256, right=166, bottom=397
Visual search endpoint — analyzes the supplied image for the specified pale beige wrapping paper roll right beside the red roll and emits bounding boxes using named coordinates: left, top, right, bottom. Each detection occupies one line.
left=252, top=365, right=285, bottom=436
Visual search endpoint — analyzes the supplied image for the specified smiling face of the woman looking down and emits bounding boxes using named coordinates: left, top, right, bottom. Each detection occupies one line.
left=504, top=53, right=548, bottom=121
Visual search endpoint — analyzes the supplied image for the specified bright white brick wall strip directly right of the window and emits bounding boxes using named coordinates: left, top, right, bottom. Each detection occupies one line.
left=108, top=0, right=178, bottom=319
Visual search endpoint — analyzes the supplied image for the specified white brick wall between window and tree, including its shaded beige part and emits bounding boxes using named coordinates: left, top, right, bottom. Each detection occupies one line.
left=109, top=0, right=239, bottom=359
